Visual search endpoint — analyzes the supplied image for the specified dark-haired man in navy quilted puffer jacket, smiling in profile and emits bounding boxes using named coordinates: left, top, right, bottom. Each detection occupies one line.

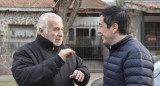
left=98, top=6, right=154, bottom=86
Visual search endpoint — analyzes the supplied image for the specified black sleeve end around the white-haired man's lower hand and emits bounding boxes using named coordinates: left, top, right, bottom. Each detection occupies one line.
left=74, top=56, right=90, bottom=86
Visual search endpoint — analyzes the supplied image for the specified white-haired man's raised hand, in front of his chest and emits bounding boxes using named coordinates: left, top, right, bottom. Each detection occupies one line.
left=58, top=49, right=75, bottom=61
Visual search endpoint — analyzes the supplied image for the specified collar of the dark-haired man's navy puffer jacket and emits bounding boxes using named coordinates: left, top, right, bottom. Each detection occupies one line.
left=105, top=34, right=132, bottom=50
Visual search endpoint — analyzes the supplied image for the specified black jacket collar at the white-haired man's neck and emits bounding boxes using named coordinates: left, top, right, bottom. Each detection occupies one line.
left=36, top=34, right=54, bottom=48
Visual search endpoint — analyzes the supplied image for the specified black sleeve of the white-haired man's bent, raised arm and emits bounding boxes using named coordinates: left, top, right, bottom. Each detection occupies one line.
left=12, top=50, right=64, bottom=86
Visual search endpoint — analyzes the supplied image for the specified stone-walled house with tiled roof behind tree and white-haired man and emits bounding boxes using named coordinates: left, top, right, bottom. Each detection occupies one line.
left=0, top=0, right=107, bottom=75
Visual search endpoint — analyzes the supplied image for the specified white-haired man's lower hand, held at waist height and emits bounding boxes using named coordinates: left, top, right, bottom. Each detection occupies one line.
left=69, top=70, right=85, bottom=82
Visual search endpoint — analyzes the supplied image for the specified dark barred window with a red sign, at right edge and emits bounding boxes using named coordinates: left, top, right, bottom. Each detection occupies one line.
left=144, top=22, right=160, bottom=54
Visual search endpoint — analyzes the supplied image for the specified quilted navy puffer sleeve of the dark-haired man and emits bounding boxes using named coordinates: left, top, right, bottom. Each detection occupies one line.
left=123, top=51, right=154, bottom=86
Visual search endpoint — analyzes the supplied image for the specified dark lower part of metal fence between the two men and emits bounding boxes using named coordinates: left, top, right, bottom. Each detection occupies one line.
left=67, top=36, right=103, bottom=60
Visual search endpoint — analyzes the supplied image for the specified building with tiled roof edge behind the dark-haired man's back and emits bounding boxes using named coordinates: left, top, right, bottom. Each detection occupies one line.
left=124, top=0, right=160, bottom=56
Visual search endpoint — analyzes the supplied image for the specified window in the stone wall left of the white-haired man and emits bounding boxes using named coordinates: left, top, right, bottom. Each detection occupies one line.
left=9, top=25, right=35, bottom=49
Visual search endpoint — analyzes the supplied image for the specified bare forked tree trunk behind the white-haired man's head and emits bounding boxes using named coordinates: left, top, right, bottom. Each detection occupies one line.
left=53, top=0, right=82, bottom=43
